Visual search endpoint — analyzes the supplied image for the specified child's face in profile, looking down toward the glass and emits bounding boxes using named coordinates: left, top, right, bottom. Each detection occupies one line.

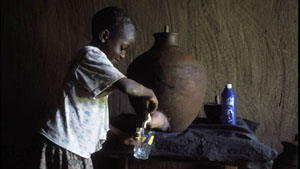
left=106, top=29, right=135, bottom=64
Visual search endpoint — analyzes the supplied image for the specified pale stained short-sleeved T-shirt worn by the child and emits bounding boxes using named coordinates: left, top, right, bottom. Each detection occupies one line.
left=40, top=46, right=125, bottom=158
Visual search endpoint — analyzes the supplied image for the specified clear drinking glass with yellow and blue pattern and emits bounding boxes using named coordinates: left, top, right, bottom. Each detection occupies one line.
left=133, top=128, right=155, bottom=160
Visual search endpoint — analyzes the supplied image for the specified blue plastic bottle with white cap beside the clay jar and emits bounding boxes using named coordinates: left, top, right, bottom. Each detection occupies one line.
left=221, top=84, right=236, bottom=125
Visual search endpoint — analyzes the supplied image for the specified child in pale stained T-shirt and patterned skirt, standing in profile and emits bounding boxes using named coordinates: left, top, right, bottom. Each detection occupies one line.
left=36, top=7, right=166, bottom=169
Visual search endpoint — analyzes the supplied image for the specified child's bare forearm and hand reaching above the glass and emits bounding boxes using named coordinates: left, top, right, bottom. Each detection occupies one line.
left=115, top=78, right=158, bottom=114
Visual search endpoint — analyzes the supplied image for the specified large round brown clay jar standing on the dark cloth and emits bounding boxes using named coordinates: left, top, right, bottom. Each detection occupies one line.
left=127, top=32, right=207, bottom=132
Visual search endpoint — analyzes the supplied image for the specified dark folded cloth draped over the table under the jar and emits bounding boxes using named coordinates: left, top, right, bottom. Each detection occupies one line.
left=151, top=118, right=277, bottom=162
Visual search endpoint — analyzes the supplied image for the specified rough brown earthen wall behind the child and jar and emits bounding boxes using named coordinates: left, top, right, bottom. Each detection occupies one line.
left=1, top=0, right=298, bottom=154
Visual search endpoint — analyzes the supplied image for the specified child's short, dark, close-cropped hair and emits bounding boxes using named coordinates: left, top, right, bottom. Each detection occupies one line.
left=92, top=7, right=134, bottom=40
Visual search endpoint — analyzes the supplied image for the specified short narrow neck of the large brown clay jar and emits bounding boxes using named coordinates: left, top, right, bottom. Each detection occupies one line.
left=153, top=32, right=178, bottom=47
